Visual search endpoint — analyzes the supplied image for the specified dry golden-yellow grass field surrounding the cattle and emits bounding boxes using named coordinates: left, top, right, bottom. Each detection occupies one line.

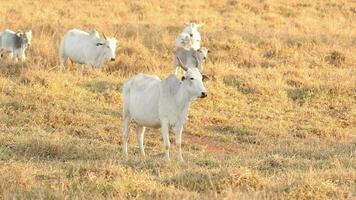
left=0, top=0, right=356, bottom=199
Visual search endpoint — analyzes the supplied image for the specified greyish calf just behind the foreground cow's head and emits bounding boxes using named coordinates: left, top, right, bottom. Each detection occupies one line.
left=173, top=47, right=209, bottom=75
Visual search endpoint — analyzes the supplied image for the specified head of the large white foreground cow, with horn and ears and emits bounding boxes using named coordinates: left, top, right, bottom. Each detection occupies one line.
left=177, top=57, right=208, bottom=98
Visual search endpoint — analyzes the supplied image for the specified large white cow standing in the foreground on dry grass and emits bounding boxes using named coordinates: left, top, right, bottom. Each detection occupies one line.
left=122, top=59, right=207, bottom=161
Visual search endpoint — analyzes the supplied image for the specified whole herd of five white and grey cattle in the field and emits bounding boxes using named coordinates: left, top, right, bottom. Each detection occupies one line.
left=0, top=23, right=209, bottom=161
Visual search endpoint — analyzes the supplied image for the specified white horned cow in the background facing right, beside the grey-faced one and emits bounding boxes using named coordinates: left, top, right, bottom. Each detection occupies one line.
left=59, top=29, right=117, bottom=68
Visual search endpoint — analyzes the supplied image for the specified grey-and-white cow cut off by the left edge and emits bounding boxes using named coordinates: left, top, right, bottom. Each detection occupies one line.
left=0, top=29, right=32, bottom=61
